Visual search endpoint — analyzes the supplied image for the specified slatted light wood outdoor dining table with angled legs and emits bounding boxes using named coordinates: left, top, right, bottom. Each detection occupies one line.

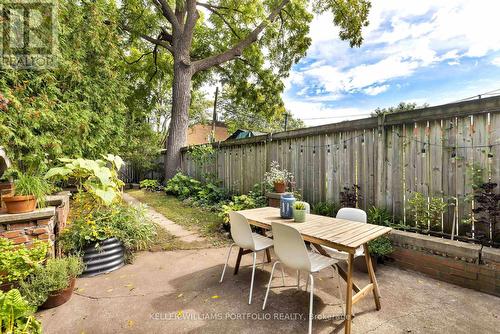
left=235, top=207, right=391, bottom=333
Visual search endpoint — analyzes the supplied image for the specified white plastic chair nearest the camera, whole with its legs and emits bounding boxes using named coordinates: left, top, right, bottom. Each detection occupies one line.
left=262, top=223, right=343, bottom=333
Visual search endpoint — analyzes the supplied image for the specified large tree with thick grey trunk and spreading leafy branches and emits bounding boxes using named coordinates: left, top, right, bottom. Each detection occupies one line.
left=120, top=0, right=370, bottom=178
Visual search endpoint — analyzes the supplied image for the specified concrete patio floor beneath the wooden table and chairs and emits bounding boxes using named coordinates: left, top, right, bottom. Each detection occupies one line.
left=37, top=248, right=500, bottom=334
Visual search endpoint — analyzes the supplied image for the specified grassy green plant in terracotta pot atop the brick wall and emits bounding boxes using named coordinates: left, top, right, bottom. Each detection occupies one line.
left=2, top=171, right=53, bottom=213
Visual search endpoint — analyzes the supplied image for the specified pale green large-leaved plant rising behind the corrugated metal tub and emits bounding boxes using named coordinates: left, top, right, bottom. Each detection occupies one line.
left=45, top=154, right=123, bottom=205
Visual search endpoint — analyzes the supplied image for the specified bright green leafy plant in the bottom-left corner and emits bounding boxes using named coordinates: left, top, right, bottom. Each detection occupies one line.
left=0, top=289, right=42, bottom=334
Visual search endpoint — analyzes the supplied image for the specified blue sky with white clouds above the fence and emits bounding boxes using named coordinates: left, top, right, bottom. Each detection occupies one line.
left=283, top=0, right=500, bottom=126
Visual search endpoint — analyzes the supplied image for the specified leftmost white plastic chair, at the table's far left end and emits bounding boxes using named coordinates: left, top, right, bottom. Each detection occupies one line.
left=219, top=212, right=274, bottom=304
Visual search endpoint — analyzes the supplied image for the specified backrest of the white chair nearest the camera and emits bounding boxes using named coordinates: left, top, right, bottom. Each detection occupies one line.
left=271, top=223, right=311, bottom=272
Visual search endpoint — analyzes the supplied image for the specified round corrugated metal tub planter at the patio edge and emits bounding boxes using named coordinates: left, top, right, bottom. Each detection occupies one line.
left=81, top=238, right=125, bottom=277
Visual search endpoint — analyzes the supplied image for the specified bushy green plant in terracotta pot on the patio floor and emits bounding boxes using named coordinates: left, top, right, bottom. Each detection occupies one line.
left=19, top=256, right=84, bottom=309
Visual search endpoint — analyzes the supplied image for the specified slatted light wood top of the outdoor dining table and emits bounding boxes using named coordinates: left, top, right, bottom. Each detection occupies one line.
left=238, top=207, right=392, bottom=254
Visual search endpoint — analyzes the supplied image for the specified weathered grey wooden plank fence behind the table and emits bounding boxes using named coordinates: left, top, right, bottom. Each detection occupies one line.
left=182, top=97, right=500, bottom=239
